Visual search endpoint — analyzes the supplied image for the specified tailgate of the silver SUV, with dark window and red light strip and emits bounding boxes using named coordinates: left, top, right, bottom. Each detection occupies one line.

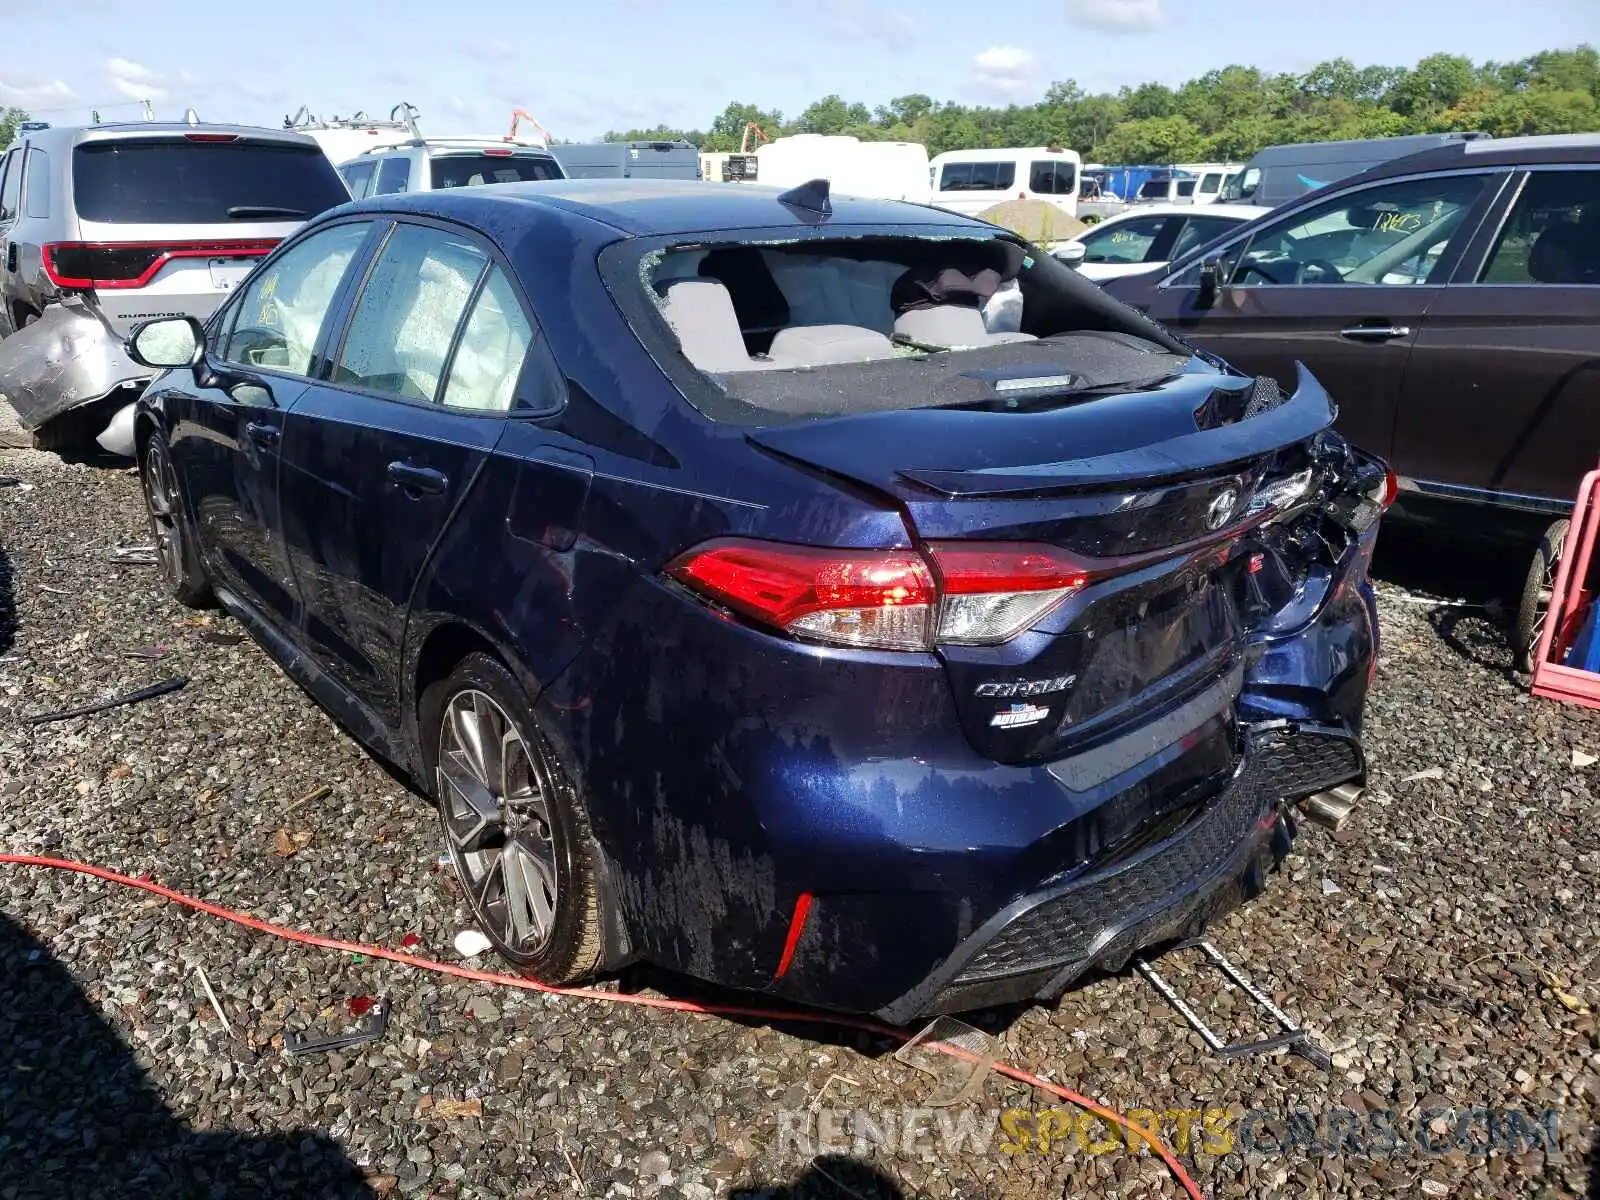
left=61, top=130, right=349, bottom=333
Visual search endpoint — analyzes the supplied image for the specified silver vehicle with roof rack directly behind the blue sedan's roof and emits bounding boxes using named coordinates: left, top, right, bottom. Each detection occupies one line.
left=339, top=138, right=566, bottom=200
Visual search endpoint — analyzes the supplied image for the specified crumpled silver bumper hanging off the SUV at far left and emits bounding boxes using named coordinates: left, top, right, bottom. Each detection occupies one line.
left=0, top=296, right=155, bottom=429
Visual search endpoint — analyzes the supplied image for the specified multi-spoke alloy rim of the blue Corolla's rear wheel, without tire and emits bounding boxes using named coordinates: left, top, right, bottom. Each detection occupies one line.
left=438, top=688, right=560, bottom=957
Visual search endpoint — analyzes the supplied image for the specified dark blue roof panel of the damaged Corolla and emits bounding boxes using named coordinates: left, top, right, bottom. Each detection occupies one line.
left=355, top=179, right=994, bottom=237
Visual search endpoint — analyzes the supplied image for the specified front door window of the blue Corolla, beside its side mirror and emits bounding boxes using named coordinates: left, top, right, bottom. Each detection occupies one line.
left=221, top=221, right=371, bottom=374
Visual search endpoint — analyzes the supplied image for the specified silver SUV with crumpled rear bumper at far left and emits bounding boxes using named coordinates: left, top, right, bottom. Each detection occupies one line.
left=0, top=122, right=350, bottom=450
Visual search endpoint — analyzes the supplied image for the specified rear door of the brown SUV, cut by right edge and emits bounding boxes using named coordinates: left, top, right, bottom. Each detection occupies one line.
left=1394, top=163, right=1600, bottom=510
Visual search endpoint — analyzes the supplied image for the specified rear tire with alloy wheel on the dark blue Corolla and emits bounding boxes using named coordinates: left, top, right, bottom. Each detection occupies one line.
left=418, top=654, right=603, bottom=984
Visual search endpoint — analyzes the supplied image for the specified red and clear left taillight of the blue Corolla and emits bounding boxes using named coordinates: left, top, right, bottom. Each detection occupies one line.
left=667, top=538, right=1088, bottom=650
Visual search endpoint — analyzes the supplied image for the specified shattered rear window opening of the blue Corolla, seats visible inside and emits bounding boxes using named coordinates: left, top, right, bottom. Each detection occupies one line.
left=608, top=230, right=1187, bottom=421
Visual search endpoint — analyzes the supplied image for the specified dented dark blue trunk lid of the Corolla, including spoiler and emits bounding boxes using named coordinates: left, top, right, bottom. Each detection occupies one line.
left=747, top=361, right=1334, bottom=762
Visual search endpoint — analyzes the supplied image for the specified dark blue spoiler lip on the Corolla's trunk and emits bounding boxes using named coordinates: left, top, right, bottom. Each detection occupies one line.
left=898, top=363, right=1338, bottom=496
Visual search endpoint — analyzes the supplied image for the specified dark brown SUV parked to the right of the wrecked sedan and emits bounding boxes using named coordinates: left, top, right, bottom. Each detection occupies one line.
left=1106, top=134, right=1600, bottom=668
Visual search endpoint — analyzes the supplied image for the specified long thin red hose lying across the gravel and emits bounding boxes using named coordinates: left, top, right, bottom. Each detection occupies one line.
left=0, top=854, right=1205, bottom=1200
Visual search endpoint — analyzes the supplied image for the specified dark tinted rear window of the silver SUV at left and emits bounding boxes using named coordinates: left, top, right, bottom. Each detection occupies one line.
left=72, top=138, right=350, bottom=226
